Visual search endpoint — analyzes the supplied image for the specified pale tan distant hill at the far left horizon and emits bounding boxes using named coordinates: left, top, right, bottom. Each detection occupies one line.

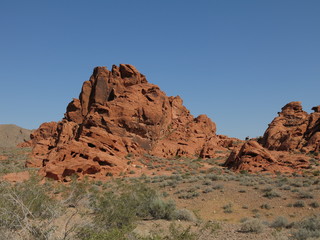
left=0, top=124, right=32, bottom=147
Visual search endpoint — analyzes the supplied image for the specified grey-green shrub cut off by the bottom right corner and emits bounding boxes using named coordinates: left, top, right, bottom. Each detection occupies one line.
left=292, top=215, right=320, bottom=240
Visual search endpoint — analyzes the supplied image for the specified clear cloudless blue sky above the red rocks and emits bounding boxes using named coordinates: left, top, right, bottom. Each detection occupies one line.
left=0, top=0, right=320, bottom=138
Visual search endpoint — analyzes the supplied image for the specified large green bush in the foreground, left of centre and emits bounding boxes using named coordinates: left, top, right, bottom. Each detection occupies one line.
left=91, top=183, right=176, bottom=229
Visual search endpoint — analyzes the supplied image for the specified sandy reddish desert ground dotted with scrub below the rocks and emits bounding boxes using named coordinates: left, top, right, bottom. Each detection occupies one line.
left=0, top=147, right=320, bottom=239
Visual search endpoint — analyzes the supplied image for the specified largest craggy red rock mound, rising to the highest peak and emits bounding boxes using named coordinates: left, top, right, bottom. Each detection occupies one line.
left=27, top=64, right=228, bottom=180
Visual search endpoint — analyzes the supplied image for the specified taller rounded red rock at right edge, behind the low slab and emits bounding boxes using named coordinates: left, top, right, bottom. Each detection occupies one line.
left=261, top=102, right=320, bottom=152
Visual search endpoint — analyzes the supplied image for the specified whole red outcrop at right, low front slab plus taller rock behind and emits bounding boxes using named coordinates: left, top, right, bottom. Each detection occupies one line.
left=225, top=102, right=320, bottom=172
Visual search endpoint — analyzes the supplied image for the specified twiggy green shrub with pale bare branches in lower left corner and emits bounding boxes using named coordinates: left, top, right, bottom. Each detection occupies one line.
left=0, top=176, right=59, bottom=239
